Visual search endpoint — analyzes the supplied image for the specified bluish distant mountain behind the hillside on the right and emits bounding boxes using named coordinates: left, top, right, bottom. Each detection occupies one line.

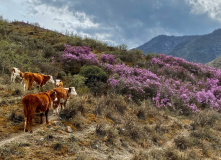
left=135, top=29, right=221, bottom=63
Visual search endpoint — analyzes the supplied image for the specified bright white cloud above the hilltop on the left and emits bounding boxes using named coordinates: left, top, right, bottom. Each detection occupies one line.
left=24, top=3, right=99, bottom=32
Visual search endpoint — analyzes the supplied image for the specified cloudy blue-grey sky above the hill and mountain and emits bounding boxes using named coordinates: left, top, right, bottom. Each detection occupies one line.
left=0, top=0, right=221, bottom=49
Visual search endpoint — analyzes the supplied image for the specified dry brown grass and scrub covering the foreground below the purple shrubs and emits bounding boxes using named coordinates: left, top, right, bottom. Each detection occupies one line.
left=0, top=76, right=221, bottom=160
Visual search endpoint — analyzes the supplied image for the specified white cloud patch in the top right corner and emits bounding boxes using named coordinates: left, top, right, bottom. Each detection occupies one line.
left=186, top=0, right=221, bottom=23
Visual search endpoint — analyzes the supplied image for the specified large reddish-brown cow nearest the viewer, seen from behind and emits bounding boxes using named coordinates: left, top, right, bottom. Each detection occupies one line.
left=22, top=90, right=57, bottom=133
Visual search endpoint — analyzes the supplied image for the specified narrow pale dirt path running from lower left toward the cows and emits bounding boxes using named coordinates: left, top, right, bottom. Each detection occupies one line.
left=0, top=115, right=59, bottom=147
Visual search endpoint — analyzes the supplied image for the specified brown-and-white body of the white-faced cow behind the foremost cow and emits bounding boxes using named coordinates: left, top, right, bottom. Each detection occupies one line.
left=53, top=87, right=70, bottom=115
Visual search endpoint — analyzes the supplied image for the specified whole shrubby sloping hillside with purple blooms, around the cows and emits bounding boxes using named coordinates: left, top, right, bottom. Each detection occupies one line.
left=0, top=20, right=221, bottom=160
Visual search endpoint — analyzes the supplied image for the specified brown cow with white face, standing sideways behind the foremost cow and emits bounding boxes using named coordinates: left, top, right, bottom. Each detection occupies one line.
left=24, top=72, right=54, bottom=91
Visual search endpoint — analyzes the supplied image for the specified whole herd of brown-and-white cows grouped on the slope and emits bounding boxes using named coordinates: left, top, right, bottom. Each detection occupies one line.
left=11, top=67, right=77, bottom=133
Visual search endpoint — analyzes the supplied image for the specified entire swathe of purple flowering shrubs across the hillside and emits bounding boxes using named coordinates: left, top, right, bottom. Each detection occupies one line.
left=58, top=45, right=221, bottom=114
